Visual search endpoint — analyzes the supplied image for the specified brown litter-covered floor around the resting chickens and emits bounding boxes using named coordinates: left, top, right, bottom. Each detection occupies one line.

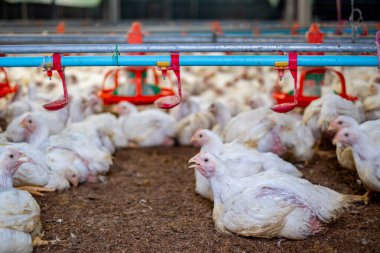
left=35, top=147, right=380, bottom=253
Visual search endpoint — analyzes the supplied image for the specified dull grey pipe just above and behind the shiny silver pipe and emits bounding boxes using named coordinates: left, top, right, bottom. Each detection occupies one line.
left=0, top=34, right=375, bottom=45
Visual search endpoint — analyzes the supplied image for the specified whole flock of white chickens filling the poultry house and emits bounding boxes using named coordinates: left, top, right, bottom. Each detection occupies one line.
left=0, top=63, right=380, bottom=252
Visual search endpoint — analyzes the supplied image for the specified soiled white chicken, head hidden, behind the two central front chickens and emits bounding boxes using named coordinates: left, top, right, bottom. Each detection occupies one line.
left=222, top=107, right=314, bottom=161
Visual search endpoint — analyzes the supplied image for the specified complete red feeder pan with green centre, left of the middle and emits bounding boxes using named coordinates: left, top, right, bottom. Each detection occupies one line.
left=99, top=67, right=175, bottom=105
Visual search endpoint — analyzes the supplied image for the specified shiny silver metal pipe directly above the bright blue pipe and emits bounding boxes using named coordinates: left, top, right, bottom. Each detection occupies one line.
left=0, top=43, right=376, bottom=54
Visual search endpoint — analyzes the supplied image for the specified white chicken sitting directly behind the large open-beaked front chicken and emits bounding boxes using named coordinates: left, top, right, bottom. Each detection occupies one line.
left=191, top=129, right=302, bottom=200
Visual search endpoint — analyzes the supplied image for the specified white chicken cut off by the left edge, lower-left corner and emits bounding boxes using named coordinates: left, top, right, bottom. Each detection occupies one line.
left=0, top=147, right=48, bottom=252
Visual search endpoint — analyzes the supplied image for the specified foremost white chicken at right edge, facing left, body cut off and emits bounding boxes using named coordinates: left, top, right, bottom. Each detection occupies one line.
left=334, top=127, right=380, bottom=204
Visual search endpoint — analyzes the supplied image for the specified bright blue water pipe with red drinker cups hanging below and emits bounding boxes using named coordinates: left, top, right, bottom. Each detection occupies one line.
left=0, top=55, right=378, bottom=67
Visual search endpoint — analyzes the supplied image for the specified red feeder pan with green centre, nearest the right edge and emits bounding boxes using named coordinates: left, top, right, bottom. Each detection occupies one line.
left=273, top=68, right=358, bottom=107
